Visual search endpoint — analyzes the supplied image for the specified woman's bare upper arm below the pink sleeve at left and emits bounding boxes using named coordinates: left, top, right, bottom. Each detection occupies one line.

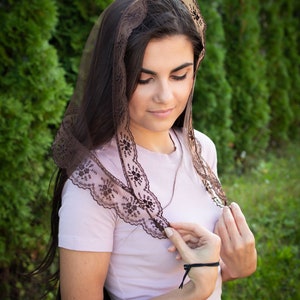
left=60, top=248, right=111, bottom=300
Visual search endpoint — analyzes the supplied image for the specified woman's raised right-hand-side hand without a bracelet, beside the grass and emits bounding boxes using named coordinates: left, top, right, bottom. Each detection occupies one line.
left=215, top=203, right=257, bottom=281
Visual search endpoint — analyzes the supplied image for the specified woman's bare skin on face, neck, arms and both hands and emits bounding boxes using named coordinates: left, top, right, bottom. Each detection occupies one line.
left=60, top=35, right=255, bottom=300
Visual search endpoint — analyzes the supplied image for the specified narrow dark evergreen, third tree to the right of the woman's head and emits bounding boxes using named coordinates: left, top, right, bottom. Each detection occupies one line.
left=261, top=0, right=293, bottom=146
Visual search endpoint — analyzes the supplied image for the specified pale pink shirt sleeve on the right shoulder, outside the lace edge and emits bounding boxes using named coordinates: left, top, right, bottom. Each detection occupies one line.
left=195, top=130, right=218, bottom=176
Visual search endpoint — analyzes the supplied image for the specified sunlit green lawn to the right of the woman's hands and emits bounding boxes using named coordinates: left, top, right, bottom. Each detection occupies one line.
left=222, top=143, right=300, bottom=300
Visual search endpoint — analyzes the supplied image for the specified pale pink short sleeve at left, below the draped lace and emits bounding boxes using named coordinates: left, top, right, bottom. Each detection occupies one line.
left=58, top=180, right=116, bottom=252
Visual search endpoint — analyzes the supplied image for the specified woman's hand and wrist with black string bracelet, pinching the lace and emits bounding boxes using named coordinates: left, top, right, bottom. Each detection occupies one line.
left=166, top=223, right=221, bottom=299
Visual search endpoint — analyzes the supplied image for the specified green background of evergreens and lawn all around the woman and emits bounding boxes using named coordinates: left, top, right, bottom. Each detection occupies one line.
left=0, top=0, right=300, bottom=300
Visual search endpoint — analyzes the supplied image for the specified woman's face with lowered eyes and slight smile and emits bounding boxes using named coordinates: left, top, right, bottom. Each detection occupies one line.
left=129, top=35, right=194, bottom=134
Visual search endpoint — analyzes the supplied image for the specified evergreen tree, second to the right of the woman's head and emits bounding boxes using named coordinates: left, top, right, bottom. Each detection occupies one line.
left=222, top=0, right=270, bottom=167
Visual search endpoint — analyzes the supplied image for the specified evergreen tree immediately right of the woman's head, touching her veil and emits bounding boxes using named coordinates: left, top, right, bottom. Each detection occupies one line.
left=193, top=0, right=234, bottom=172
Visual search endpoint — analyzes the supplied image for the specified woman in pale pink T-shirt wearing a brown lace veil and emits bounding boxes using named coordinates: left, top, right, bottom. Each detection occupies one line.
left=39, top=0, right=256, bottom=299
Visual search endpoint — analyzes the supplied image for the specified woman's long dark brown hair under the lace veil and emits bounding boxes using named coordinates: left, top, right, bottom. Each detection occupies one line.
left=34, top=0, right=203, bottom=298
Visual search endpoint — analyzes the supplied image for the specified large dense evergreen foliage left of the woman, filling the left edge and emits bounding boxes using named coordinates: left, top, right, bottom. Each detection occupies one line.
left=0, top=0, right=70, bottom=299
